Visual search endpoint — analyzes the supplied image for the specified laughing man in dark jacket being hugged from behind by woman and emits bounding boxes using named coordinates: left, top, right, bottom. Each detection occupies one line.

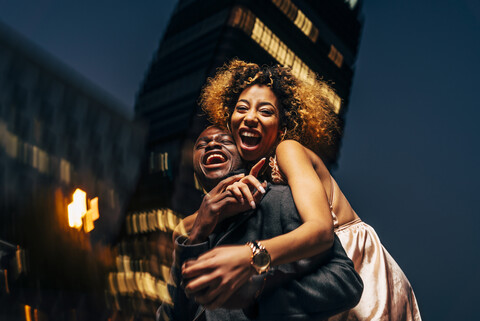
left=157, top=126, right=363, bottom=320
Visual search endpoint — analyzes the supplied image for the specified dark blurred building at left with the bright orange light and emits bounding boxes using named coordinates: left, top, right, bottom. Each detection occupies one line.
left=0, top=21, right=146, bottom=320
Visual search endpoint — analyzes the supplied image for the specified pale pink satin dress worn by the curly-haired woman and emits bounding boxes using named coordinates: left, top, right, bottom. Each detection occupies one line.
left=269, top=158, right=422, bottom=321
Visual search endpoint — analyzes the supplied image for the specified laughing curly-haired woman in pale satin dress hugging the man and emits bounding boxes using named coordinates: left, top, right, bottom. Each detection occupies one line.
left=184, top=60, right=420, bottom=320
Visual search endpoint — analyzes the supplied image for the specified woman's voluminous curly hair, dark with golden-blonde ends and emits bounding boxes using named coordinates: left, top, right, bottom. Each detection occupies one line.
left=200, top=59, right=339, bottom=153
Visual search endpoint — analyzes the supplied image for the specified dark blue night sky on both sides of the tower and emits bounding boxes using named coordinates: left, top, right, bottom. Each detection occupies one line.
left=0, top=0, right=480, bottom=320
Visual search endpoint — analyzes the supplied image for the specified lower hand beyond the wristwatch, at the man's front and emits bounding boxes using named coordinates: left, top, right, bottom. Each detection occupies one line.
left=182, top=245, right=255, bottom=309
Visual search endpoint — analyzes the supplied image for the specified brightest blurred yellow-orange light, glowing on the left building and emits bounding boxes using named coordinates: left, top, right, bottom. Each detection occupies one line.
left=68, top=188, right=100, bottom=233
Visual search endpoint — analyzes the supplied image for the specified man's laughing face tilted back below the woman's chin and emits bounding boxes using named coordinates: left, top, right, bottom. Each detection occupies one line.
left=193, top=127, right=242, bottom=191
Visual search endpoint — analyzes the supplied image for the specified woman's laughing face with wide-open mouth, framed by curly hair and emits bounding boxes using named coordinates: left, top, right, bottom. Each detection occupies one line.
left=230, top=85, right=280, bottom=161
